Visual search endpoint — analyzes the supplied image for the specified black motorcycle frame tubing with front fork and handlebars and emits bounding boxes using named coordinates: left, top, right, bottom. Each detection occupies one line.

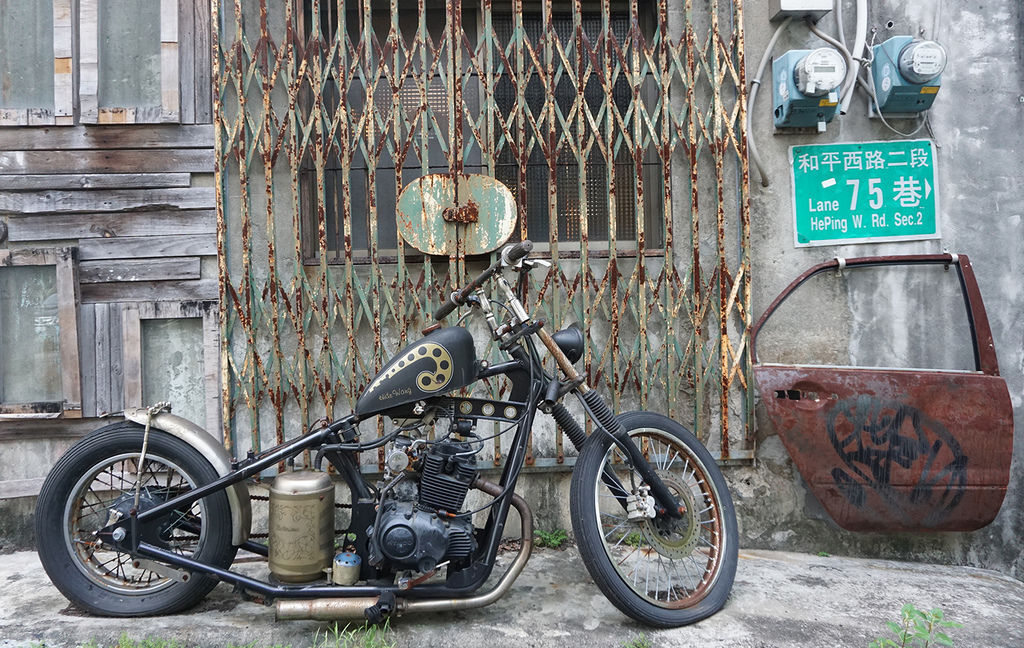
left=97, top=242, right=680, bottom=600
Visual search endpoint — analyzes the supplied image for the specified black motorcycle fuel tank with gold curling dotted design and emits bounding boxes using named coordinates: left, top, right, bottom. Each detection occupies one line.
left=355, top=327, right=477, bottom=419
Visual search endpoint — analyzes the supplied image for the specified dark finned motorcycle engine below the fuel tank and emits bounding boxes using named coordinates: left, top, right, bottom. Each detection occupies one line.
left=367, top=441, right=476, bottom=572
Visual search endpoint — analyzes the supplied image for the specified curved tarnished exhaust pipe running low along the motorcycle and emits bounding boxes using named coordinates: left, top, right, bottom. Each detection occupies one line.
left=274, top=477, right=534, bottom=621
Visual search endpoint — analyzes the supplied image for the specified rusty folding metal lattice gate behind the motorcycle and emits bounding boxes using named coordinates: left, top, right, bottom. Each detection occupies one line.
left=212, top=0, right=753, bottom=463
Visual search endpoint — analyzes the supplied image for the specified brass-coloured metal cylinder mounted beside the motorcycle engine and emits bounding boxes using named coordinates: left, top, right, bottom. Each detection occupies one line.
left=267, top=471, right=334, bottom=582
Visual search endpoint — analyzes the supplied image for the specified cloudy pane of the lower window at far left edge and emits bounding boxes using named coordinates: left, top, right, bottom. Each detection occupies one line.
left=0, top=265, right=62, bottom=404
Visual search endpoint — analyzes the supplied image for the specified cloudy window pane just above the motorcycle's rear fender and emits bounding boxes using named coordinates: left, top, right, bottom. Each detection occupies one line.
left=141, top=317, right=206, bottom=426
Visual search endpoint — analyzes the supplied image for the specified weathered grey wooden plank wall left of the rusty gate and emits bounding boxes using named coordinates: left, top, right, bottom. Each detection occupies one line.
left=0, top=0, right=220, bottom=501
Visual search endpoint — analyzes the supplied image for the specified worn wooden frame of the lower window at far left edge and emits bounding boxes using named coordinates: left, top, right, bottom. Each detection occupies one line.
left=0, top=248, right=82, bottom=420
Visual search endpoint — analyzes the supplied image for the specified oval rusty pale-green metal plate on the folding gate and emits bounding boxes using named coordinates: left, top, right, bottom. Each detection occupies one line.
left=397, top=173, right=517, bottom=255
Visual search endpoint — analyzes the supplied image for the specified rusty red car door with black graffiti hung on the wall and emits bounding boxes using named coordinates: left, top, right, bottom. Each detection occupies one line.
left=752, top=254, right=1013, bottom=531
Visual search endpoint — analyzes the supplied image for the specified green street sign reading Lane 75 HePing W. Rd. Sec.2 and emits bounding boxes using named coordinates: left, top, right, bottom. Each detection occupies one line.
left=790, top=139, right=939, bottom=248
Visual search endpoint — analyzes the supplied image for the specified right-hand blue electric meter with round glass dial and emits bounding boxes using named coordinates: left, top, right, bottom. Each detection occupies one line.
left=871, top=36, right=946, bottom=117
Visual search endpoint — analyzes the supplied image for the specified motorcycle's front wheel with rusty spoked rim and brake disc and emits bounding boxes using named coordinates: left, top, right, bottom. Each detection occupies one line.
left=569, top=412, right=738, bottom=628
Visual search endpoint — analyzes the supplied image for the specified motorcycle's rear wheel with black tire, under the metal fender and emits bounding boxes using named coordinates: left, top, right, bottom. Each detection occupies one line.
left=36, top=422, right=238, bottom=616
